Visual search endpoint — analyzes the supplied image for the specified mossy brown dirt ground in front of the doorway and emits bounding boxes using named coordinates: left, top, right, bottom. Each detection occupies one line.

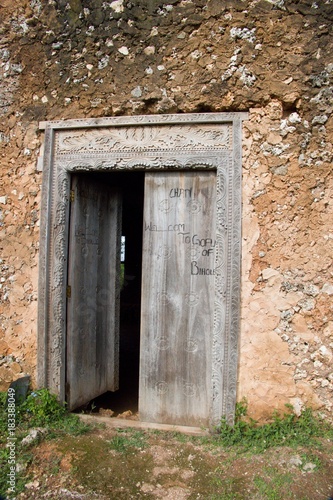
left=17, top=418, right=333, bottom=500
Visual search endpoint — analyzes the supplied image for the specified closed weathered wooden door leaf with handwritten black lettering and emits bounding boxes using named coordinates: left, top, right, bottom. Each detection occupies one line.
left=139, top=172, right=216, bottom=425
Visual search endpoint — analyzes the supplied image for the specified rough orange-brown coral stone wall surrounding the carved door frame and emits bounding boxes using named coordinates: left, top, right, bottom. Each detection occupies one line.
left=0, top=0, right=333, bottom=418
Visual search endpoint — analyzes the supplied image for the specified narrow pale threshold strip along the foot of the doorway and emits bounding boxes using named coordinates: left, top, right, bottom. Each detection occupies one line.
left=78, top=413, right=210, bottom=436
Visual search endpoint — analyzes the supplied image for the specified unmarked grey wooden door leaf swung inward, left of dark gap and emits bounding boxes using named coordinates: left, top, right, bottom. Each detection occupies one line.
left=66, top=175, right=121, bottom=409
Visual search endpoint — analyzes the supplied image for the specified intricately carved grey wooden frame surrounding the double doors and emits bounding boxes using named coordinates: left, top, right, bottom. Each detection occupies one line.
left=37, top=113, right=247, bottom=425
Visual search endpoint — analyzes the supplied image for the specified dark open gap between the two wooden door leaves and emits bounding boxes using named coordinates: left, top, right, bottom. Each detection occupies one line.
left=68, top=172, right=144, bottom=416
